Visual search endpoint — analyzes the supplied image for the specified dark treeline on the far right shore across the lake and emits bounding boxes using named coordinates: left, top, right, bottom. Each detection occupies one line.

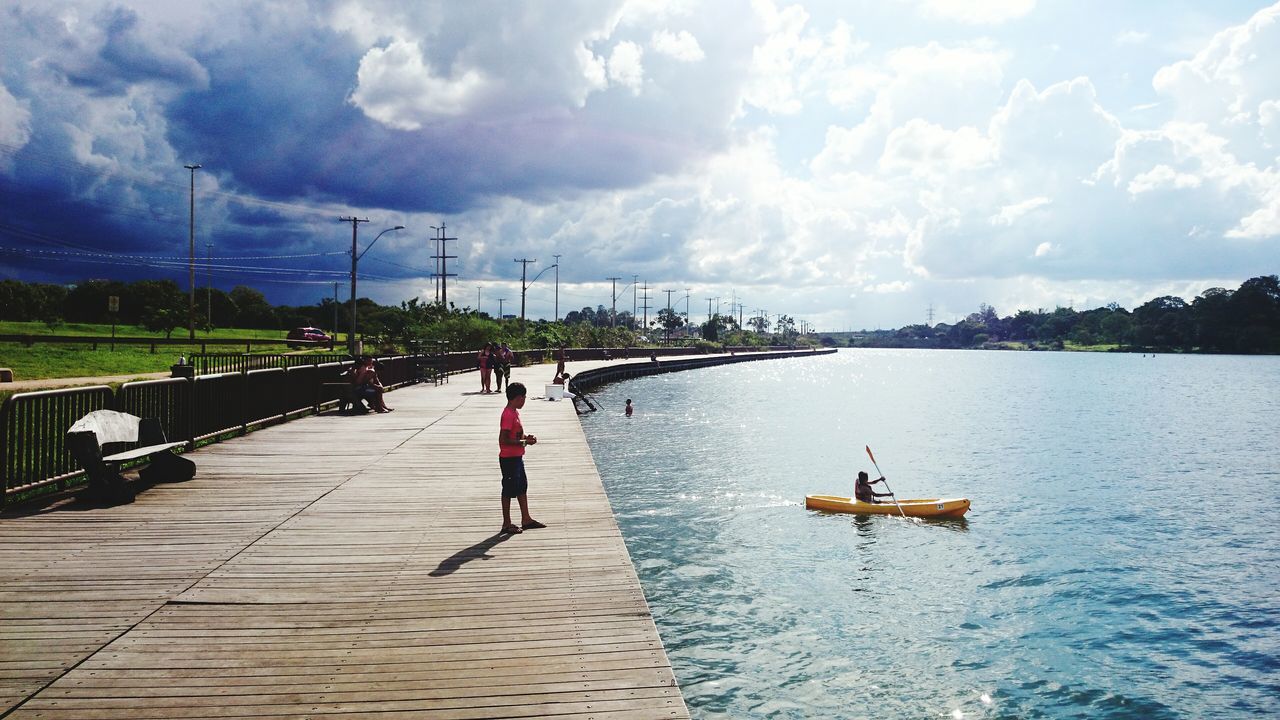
left=849, top=275, right=1280, bottom=354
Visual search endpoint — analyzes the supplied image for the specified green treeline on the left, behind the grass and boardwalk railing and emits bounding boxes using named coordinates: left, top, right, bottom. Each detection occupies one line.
left=0, top=279, right=817, bottom=351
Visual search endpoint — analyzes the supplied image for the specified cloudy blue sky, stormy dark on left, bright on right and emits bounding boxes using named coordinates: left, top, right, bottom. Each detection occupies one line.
left=0, top=0, right=1280, bottom=331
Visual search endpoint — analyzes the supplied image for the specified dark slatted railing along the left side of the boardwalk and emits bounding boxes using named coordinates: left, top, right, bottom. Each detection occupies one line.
left=0, top=355, right=419, bottom=507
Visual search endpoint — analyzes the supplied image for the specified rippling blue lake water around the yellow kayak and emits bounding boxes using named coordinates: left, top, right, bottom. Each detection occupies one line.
left=582, top=350, right=1280, bottom=719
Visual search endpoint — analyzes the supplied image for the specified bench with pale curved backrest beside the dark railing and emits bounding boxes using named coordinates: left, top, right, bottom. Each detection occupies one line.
left=67, top=410, right=196, bottom=502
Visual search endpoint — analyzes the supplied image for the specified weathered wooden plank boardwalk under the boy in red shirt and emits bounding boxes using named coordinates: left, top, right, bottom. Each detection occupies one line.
left=0, top=363, right=689, bottom=720
